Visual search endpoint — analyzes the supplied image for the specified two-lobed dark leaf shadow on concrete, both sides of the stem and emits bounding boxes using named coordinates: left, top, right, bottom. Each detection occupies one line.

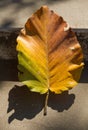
left=7, top=86, right=75, bottom=123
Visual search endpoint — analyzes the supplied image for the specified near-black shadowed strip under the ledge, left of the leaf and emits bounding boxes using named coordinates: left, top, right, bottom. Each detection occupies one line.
left=0, top=59, right=18, bottom=81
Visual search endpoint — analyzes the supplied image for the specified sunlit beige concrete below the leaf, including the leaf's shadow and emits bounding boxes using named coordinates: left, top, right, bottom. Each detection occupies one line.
left=0, top=81, right=88, bottom=130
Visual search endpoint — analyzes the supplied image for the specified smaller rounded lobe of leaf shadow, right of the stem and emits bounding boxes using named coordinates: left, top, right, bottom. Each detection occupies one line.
left=48, top=91, right=75, bottom=112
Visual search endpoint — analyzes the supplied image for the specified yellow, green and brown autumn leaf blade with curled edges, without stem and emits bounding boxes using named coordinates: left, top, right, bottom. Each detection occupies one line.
left=17, top=6, right=83, bottom=114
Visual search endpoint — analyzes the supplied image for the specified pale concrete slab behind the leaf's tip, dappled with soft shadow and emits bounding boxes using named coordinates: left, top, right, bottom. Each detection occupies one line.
left=0, top=0, right=88, bottom=28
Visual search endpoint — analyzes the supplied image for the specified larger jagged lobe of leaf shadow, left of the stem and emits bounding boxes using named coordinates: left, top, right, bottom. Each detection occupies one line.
left=7, top=85, right=44, bottom=123
